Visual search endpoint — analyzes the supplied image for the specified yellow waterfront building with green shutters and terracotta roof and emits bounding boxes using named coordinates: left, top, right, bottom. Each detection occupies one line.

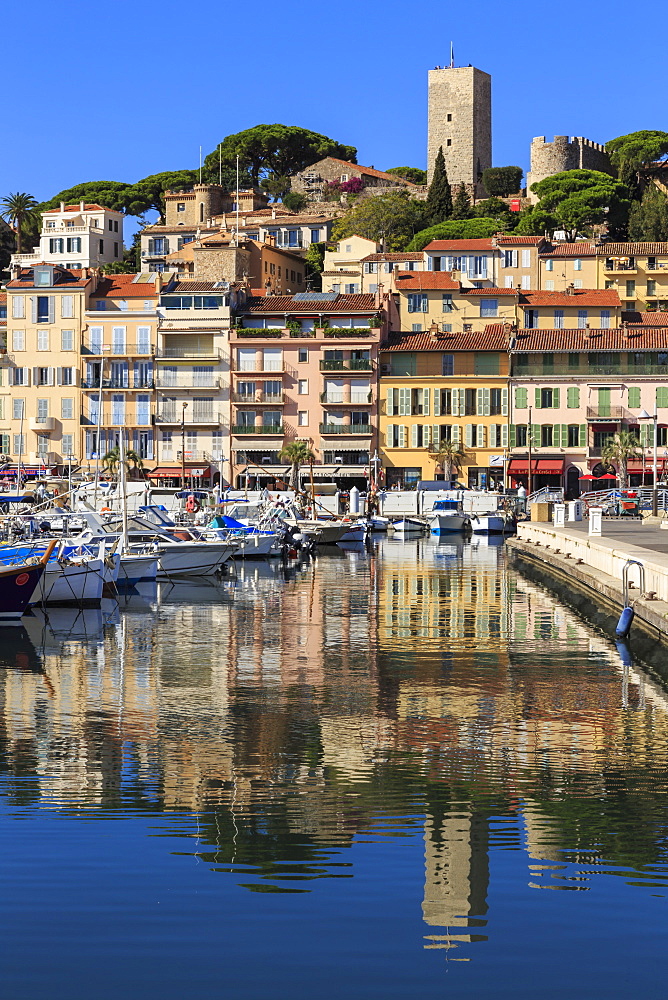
left=380, top=323, right=511, bottom=487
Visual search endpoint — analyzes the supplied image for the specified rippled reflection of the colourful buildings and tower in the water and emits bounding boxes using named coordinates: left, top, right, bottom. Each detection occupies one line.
left=0, top=539, right=668, bottom=948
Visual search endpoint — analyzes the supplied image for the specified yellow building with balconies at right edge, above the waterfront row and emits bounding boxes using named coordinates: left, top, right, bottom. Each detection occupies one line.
left=592, top=243, right=668, bottom=311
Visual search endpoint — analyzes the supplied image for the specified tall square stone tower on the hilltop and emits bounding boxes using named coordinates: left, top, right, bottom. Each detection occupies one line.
left=427, top=66, right=492, bottom=198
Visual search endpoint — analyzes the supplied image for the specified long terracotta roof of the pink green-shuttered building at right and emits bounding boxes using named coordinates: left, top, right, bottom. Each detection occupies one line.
left=515, top=325, right=668, bottom=354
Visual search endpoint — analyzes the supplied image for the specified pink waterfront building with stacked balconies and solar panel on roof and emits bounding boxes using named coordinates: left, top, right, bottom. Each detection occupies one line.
left=230, top=292, right=394, bottom=487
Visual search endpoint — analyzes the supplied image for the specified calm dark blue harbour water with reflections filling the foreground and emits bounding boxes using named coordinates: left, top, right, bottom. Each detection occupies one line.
left=0, top=538, right=668, bottom=1000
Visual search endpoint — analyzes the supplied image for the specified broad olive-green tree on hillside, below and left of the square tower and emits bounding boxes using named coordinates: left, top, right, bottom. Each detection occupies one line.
left=332, top=191, right=425, bottom=251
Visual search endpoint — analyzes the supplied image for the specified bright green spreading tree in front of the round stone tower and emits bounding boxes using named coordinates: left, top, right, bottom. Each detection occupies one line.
left=531, top=170, right=631, bottom=243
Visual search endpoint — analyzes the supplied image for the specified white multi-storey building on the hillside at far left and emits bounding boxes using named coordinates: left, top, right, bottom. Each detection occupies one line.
left=12, top=201, right=124, bottom=270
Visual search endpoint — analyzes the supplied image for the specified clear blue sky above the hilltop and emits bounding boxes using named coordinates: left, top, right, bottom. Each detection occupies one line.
left=0, top=0, right=668, bottom=207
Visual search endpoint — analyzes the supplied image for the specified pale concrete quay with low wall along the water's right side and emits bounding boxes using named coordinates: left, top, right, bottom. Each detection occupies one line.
left=507, top=520, right=668, bottom=645
